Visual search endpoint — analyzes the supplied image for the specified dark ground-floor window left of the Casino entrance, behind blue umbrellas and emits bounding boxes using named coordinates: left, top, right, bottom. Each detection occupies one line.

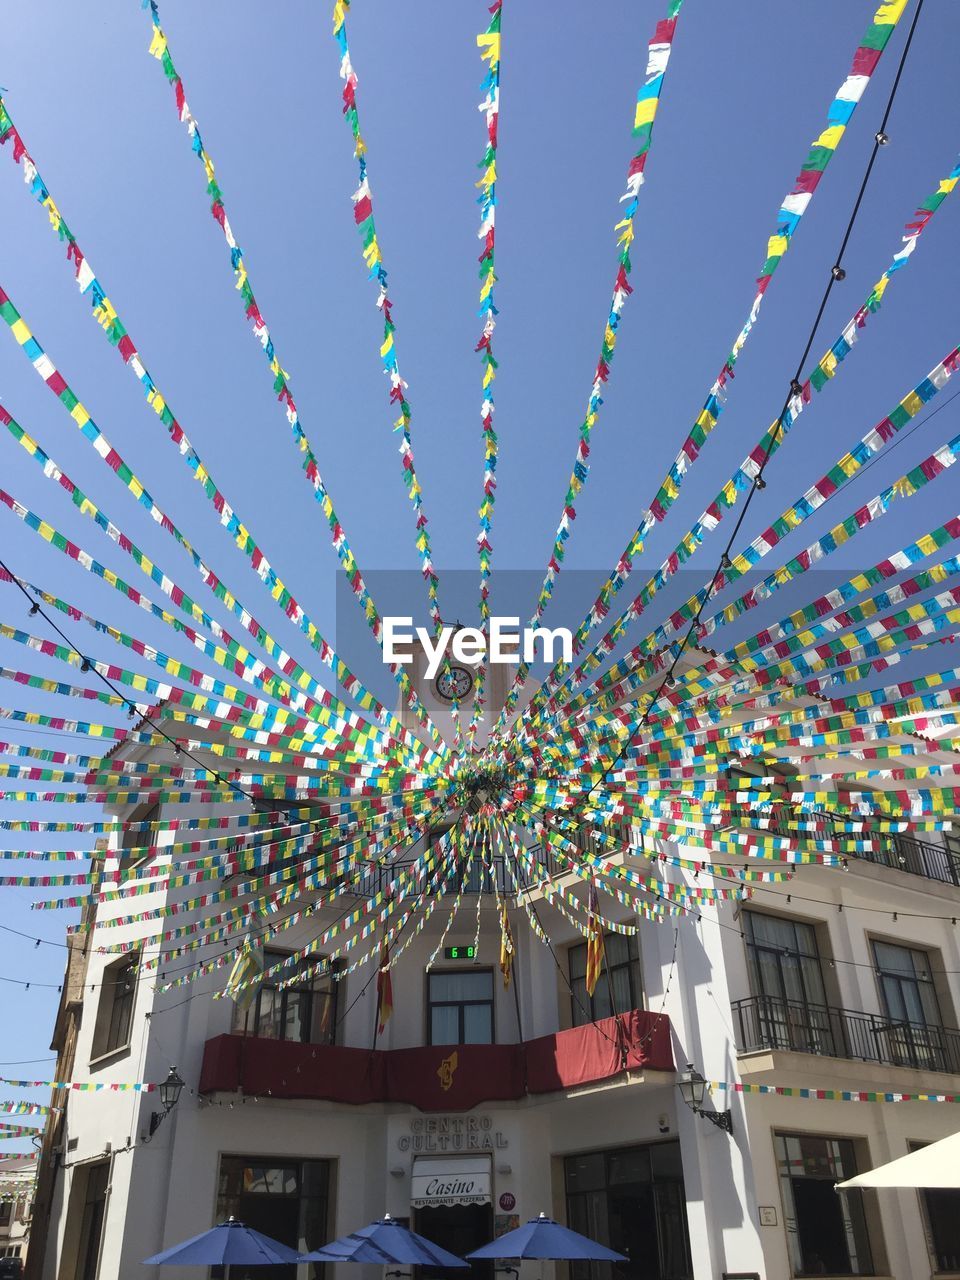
left=212, top=1156, right=332, bottom=1280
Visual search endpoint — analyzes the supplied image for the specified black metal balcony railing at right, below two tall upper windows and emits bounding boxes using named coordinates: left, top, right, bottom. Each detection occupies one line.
left=732, top=996, right=960, bottom=1075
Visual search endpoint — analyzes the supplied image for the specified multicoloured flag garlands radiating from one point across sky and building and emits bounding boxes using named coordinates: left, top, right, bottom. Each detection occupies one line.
left=0, top=0, right=960, bottom=1141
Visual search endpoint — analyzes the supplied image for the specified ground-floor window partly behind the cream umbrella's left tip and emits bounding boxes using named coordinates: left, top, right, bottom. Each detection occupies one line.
left=774, top=1133, right=876, bottom=1276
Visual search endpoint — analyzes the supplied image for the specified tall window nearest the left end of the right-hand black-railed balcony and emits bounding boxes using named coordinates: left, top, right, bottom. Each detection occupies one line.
left=742, top=911, right=836, bottom=1055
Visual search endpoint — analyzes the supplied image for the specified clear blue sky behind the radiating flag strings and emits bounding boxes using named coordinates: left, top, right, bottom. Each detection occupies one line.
left=0, top=0, right=960, bottom=1141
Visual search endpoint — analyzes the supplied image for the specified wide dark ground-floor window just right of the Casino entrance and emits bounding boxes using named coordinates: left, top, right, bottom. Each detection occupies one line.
left=563, top=1142, right=692, bottom=1280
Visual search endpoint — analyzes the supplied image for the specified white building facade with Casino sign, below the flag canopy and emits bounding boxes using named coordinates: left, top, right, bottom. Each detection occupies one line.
left=28, top=670, right=960, bottom=1280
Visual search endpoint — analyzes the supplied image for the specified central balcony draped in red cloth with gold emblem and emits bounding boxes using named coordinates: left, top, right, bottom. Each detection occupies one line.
left=200, top=1009, right=673, bottom=1111
